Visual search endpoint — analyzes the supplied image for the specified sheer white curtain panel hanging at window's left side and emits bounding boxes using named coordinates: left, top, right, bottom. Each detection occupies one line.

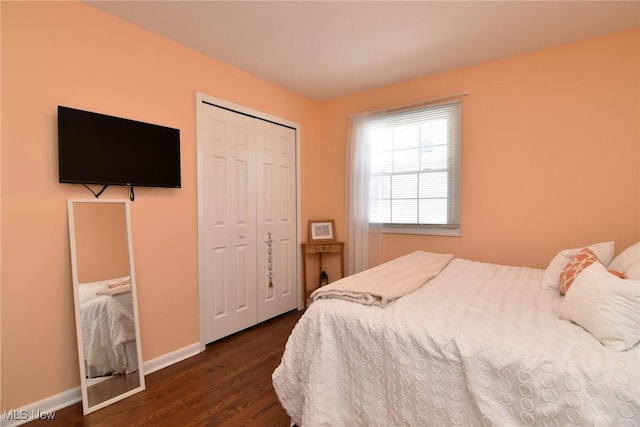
left=347, top=112, right=384, bottom=275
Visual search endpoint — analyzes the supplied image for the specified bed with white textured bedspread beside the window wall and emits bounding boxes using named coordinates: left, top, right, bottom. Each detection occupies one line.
left=272, top=242, right=640, bottom=427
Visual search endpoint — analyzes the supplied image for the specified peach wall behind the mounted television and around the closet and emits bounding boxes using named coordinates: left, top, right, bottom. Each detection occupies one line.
left=0, top=2, right=318, bottom=410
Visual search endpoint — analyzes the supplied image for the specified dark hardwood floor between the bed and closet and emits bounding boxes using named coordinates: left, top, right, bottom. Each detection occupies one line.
left=30, top=311, right=302, bottom=427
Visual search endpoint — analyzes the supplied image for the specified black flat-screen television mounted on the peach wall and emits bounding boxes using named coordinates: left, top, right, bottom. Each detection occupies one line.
left=58, top=106, right=181, bottom=188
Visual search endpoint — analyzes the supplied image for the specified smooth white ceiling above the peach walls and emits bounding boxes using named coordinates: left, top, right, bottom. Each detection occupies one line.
left=88, top=0, right=640, bottom=101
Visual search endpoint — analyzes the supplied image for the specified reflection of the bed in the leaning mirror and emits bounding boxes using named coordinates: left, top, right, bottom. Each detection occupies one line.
left=79, top=277, right=138, bottom=378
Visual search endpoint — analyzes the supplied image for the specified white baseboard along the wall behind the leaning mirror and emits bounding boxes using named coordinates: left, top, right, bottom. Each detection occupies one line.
left=0, top=343, right=200, bottom=427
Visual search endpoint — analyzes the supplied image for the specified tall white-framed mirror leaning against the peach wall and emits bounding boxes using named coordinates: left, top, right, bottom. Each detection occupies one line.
left=68, top=199, right=145, bottom=414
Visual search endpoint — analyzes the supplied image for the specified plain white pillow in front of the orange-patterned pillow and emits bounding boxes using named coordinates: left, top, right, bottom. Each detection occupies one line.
left=558, top=262, right=640, bottom=351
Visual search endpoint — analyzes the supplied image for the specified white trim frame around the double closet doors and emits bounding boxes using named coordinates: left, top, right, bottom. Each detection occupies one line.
left=196, top=92, right=304, bottom=352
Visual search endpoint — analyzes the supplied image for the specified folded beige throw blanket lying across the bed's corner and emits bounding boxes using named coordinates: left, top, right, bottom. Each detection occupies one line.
left=311, top=251, right=453, bottom=307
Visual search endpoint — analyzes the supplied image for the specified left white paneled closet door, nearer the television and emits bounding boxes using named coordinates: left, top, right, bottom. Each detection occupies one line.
left=198, top=107, right=262, bottom=342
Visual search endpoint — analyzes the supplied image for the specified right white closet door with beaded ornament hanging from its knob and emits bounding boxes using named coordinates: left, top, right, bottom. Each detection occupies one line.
left=256, top=120, right=298, bottom=322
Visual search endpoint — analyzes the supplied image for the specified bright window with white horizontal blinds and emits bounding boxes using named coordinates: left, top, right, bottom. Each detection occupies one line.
left=369, top=101, right=460, bottom=229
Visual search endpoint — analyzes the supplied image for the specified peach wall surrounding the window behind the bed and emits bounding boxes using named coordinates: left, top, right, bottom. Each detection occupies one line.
left=322, top=30, right=640, bottom=267
